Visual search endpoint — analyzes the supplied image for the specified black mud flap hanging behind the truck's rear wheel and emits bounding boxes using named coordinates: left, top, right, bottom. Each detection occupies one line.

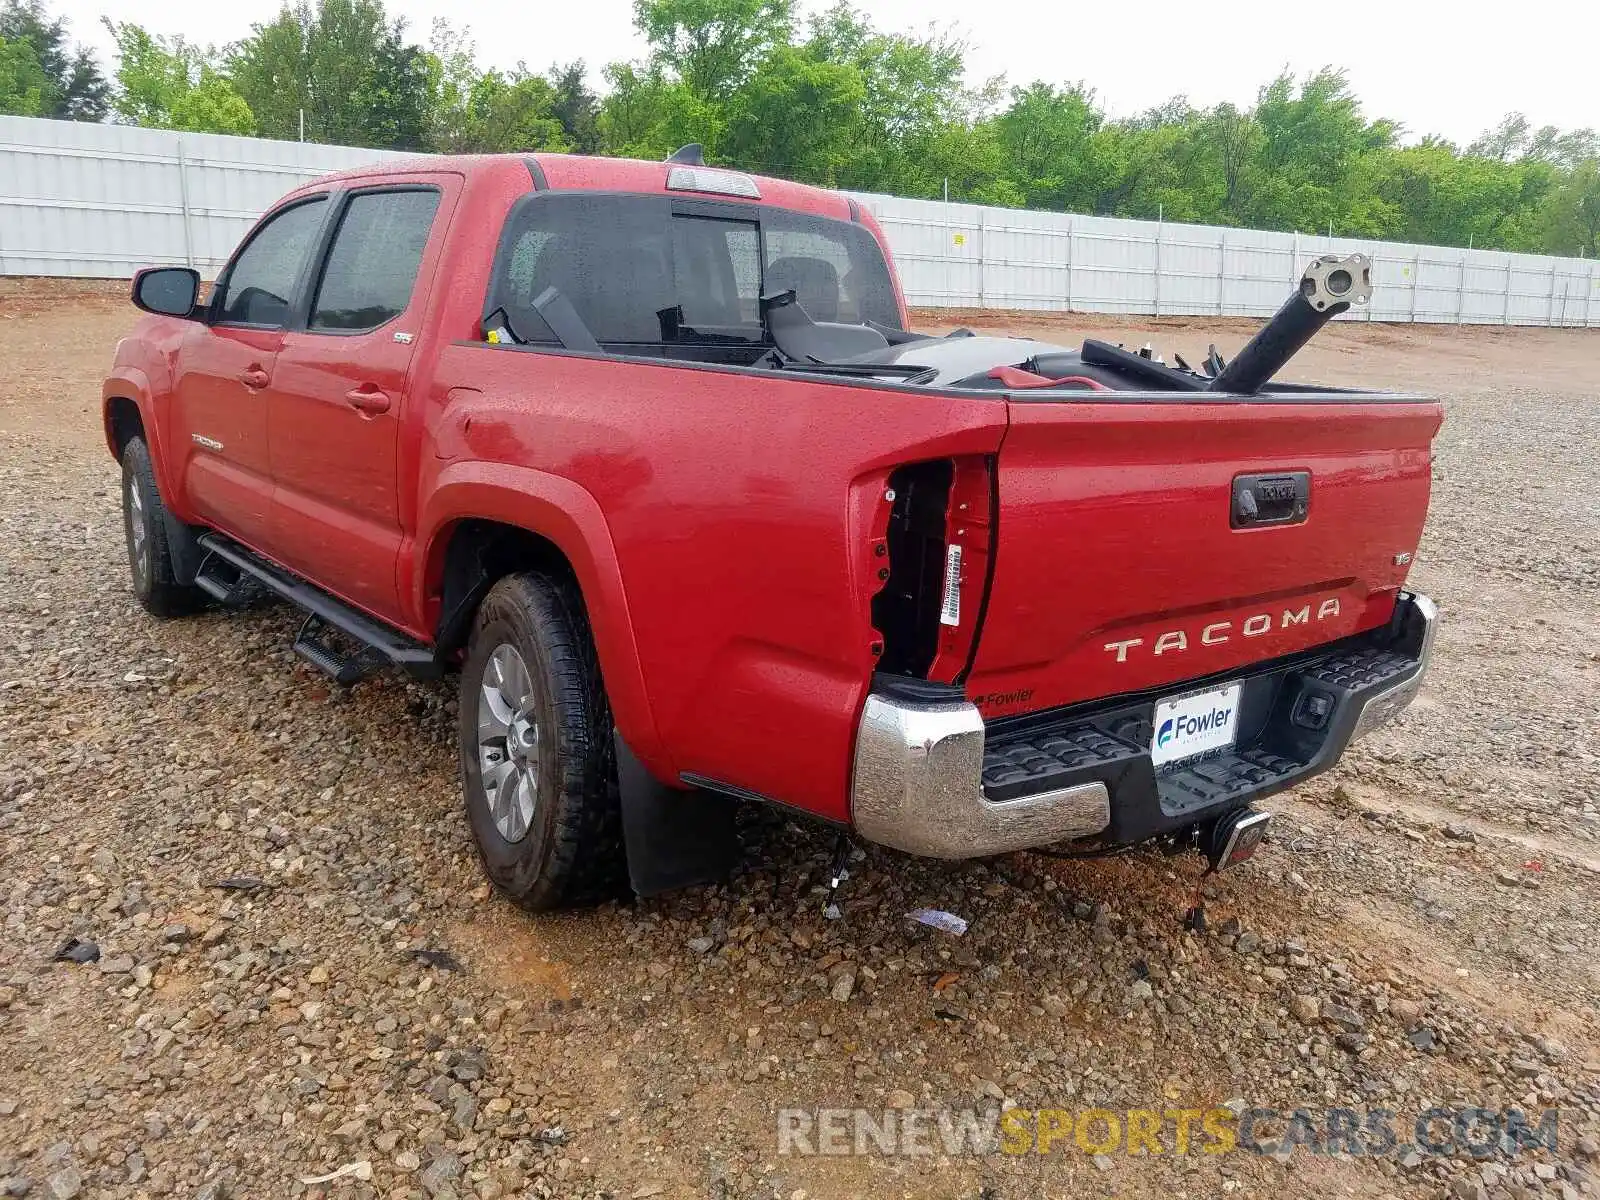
left=613, top=734, right=739, bottom=896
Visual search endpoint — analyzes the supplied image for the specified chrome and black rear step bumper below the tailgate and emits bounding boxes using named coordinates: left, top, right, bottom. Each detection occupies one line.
left=851, top=592, right=1438, bottom=859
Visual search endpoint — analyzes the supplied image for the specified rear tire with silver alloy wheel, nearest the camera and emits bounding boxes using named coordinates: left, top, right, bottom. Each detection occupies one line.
left=459, top=573, right=627, bottom=912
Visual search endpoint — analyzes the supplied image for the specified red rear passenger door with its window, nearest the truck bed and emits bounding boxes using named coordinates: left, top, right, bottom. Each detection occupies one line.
left=267, top=185, right=459, bottom=630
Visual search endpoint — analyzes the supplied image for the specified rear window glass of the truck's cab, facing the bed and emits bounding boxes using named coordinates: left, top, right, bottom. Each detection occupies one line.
left=485, top=192, right=899, bottom=346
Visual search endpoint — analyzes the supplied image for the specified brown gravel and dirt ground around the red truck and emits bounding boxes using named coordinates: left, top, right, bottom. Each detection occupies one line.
left=0, top=290, right=1600, bottom=1200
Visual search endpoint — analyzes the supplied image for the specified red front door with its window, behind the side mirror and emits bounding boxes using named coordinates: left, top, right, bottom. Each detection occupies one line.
left=171, top=195, right=328, bottom=549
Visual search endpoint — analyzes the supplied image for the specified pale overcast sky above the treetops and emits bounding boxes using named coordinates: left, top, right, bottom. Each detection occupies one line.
left=50, top=0, right=1600, bottom=142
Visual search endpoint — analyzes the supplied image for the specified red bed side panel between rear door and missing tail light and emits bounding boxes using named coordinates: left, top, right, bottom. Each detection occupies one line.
left=427, top=346, right=1006, bottom=821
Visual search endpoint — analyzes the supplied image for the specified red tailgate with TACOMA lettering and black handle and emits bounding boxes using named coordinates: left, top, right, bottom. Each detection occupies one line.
left=966, top=394, right=1442, bottom=717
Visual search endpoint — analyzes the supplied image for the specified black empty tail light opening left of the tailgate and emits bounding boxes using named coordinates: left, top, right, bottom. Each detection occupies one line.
left=872, top=459, right=955, bottom=678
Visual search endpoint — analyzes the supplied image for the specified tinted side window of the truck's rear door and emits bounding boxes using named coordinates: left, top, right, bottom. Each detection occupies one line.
left=310, top=189, right=438, bottom=333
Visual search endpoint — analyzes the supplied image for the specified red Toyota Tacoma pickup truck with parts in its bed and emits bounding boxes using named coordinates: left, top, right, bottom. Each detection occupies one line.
left=104, top=152, right=1442, bottom=907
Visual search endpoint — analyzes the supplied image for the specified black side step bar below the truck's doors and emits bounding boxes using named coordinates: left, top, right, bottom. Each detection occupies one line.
left=195, top=533, right=443, bottom=683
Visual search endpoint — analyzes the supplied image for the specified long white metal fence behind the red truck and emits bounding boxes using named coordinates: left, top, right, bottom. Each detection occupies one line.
left=0, top=117, right=1600, bottom=328
